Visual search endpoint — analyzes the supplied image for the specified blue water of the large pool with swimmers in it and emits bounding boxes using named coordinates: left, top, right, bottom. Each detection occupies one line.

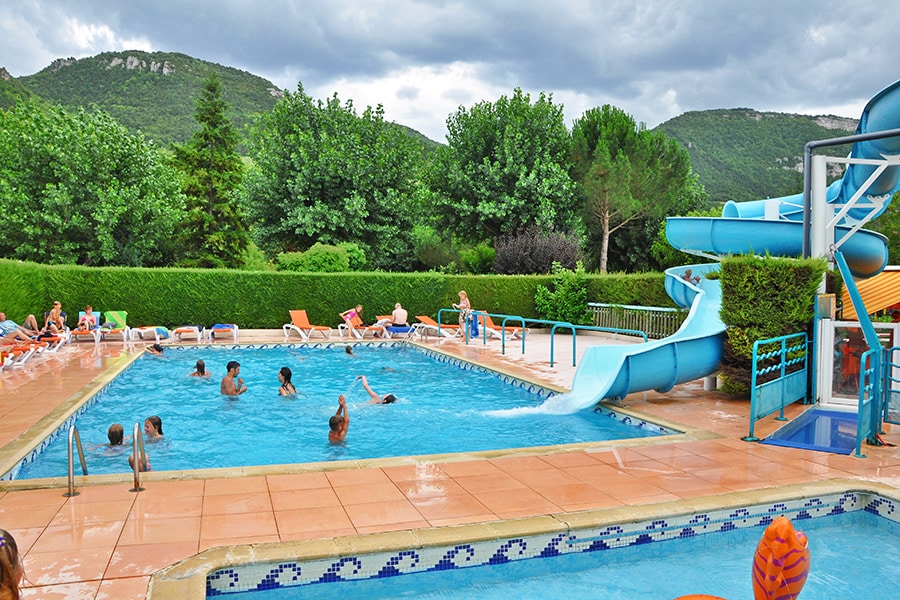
left=10, top=345, right=660, bottom=478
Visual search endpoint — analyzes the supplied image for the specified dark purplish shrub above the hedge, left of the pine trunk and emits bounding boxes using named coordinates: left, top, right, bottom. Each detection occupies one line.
left=493, top=227, right=583, bottom=275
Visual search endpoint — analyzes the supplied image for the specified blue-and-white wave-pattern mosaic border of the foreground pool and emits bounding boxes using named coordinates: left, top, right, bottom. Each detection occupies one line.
left=206, top=491, right=900, bottom=597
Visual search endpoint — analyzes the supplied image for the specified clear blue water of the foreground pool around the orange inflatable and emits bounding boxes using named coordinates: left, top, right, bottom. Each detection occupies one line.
left=216, top=511, right=900, bottom=600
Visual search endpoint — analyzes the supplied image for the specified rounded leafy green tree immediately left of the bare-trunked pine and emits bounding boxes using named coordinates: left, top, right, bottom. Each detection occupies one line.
left=428, top=88, right=577, bottom=243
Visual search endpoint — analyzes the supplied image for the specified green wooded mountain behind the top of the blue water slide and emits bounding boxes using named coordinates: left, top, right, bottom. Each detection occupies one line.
left=655, top=108, right=857, bottom=202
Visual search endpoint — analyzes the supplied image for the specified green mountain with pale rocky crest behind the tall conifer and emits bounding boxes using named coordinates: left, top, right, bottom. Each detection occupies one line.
left=16, top=50, right=284, bottom=147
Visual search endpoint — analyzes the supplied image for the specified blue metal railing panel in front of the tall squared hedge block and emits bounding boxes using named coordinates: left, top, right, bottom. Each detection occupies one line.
left=742, top=333, right=809, bottom=442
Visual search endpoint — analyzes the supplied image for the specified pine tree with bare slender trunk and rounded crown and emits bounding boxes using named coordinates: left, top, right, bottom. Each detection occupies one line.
left=571, top=104, right=691, bottom=273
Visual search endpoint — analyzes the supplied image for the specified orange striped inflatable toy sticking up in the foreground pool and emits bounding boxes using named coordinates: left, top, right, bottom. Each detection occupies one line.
left=753, top=517, right=809, bottom=600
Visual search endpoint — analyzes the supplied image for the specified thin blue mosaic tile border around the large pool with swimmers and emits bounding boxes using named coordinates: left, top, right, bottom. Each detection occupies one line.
left=0, top=341, right=668, bottom=481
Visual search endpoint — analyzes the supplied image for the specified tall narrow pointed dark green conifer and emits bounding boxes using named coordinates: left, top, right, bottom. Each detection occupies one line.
left=173, top=71, right=250, bottom=268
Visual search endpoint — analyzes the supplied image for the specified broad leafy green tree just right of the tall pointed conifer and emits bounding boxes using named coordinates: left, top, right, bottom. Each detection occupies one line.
left=243, top=85, right=421, bottom=271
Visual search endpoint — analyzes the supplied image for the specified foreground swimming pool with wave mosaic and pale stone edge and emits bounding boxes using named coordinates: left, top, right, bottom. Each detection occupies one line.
left=150, top=482, right=900, bottom=600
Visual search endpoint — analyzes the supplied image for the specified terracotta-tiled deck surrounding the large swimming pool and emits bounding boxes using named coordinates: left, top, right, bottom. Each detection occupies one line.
left=0, top=330, right=900, bottom=599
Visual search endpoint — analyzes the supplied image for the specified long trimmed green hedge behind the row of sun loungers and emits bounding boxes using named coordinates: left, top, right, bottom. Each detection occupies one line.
left=0, top=259, right=673, bottom=329
